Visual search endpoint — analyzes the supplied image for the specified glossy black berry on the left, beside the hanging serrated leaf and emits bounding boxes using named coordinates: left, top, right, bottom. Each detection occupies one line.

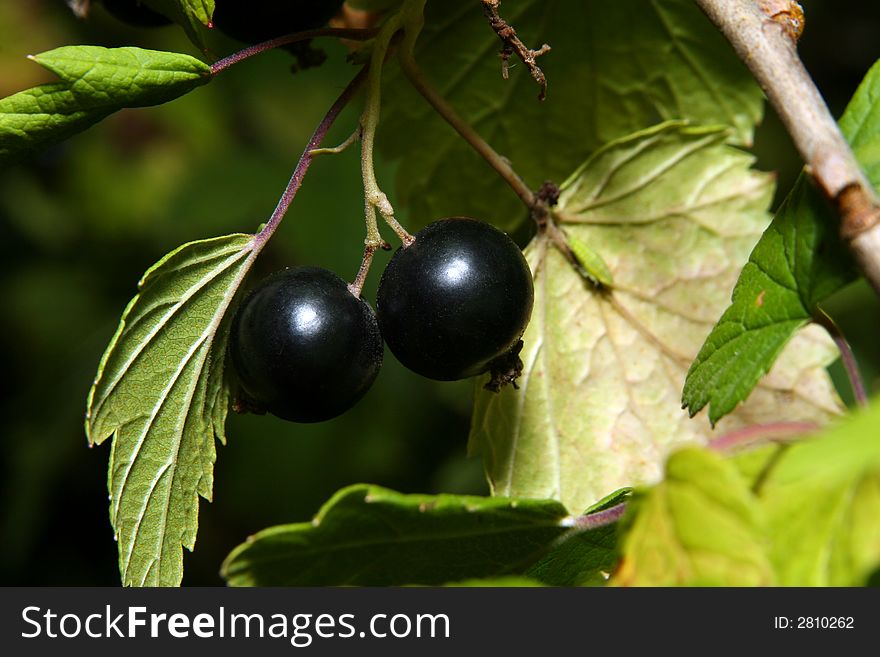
left=229, top=267, right=383, bottom=422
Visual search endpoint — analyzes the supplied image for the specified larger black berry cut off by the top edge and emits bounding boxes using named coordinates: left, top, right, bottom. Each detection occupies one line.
left=212, top=0, right=343, bottom=43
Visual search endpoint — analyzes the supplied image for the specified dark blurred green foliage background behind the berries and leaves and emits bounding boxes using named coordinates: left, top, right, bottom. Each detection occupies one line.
left=0, top=0, right=880, bottom=585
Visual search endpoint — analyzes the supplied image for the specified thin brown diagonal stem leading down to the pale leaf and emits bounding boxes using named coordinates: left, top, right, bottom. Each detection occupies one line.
left=399, top=49, right=536, bottom=209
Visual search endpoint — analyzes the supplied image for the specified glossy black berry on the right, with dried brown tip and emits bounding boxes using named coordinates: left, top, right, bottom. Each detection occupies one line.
left=376, top=217, right=534, bottom=381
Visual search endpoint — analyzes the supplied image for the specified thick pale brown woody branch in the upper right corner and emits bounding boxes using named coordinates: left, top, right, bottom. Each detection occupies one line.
left=697, top=0, right=880, bottom=295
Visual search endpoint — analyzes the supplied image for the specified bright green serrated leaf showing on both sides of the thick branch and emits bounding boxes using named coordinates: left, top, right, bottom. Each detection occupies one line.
left=682, top=64, right=880, bottom=422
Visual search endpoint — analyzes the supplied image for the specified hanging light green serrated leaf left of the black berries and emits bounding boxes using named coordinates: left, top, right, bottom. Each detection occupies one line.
left=86, top=235, right=255, bottom=586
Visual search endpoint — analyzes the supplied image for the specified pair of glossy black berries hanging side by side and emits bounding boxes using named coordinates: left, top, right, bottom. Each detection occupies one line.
left=229, top=217, right=534, bottom=422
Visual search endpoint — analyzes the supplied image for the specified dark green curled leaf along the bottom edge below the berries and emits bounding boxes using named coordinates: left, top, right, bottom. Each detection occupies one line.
left=223, top=485, right=613, bottom=586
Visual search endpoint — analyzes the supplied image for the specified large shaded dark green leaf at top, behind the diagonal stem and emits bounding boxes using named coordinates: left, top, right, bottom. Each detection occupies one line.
left=378, top=0, right=763, bottom=228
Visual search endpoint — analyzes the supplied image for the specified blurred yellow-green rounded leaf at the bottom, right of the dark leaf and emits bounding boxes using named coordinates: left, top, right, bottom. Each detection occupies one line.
left=612, top=448, right=775, bottom=586
